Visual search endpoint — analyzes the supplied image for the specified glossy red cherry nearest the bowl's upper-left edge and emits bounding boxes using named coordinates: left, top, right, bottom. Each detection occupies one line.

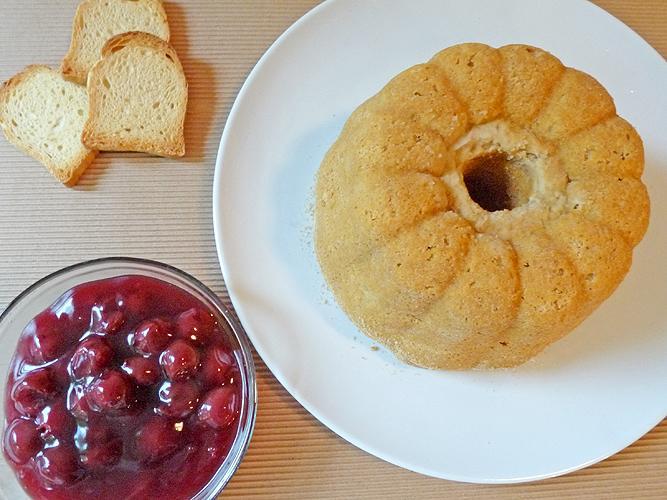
left=22, top=309, right=69, bottom=364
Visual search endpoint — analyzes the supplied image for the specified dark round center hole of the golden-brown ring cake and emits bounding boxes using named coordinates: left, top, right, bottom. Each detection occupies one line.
left=463, top=152, right=533, bottom=212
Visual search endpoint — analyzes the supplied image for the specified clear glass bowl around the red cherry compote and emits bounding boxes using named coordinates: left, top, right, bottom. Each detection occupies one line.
left=0, top=257, right=257, bottom=500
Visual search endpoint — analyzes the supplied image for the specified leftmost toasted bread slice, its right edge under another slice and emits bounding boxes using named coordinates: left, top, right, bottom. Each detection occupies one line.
left=0, top=65, right=97, bottom=186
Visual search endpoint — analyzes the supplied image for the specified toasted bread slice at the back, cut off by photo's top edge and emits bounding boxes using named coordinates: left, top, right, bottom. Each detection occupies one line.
left=60, top=0, right=169, bottom=85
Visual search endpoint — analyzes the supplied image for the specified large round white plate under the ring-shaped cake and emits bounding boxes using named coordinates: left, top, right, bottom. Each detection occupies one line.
left=213, top=0, right=667, bottom=483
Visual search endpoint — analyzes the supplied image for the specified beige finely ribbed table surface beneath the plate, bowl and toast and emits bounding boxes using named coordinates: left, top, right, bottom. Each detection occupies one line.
left=0, top=0, right=667, bottom=498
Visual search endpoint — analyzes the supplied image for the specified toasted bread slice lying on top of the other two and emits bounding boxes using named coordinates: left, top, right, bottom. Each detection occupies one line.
left=81, top=32, right=188, bottom=157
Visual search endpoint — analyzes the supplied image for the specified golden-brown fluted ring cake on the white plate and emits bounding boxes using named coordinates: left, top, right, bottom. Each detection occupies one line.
left=315, top=43, right=649, bottom=369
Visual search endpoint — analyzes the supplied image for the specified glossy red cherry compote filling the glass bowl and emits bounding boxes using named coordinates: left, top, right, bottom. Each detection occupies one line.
left=3, top=275, right=242, bottom=500
